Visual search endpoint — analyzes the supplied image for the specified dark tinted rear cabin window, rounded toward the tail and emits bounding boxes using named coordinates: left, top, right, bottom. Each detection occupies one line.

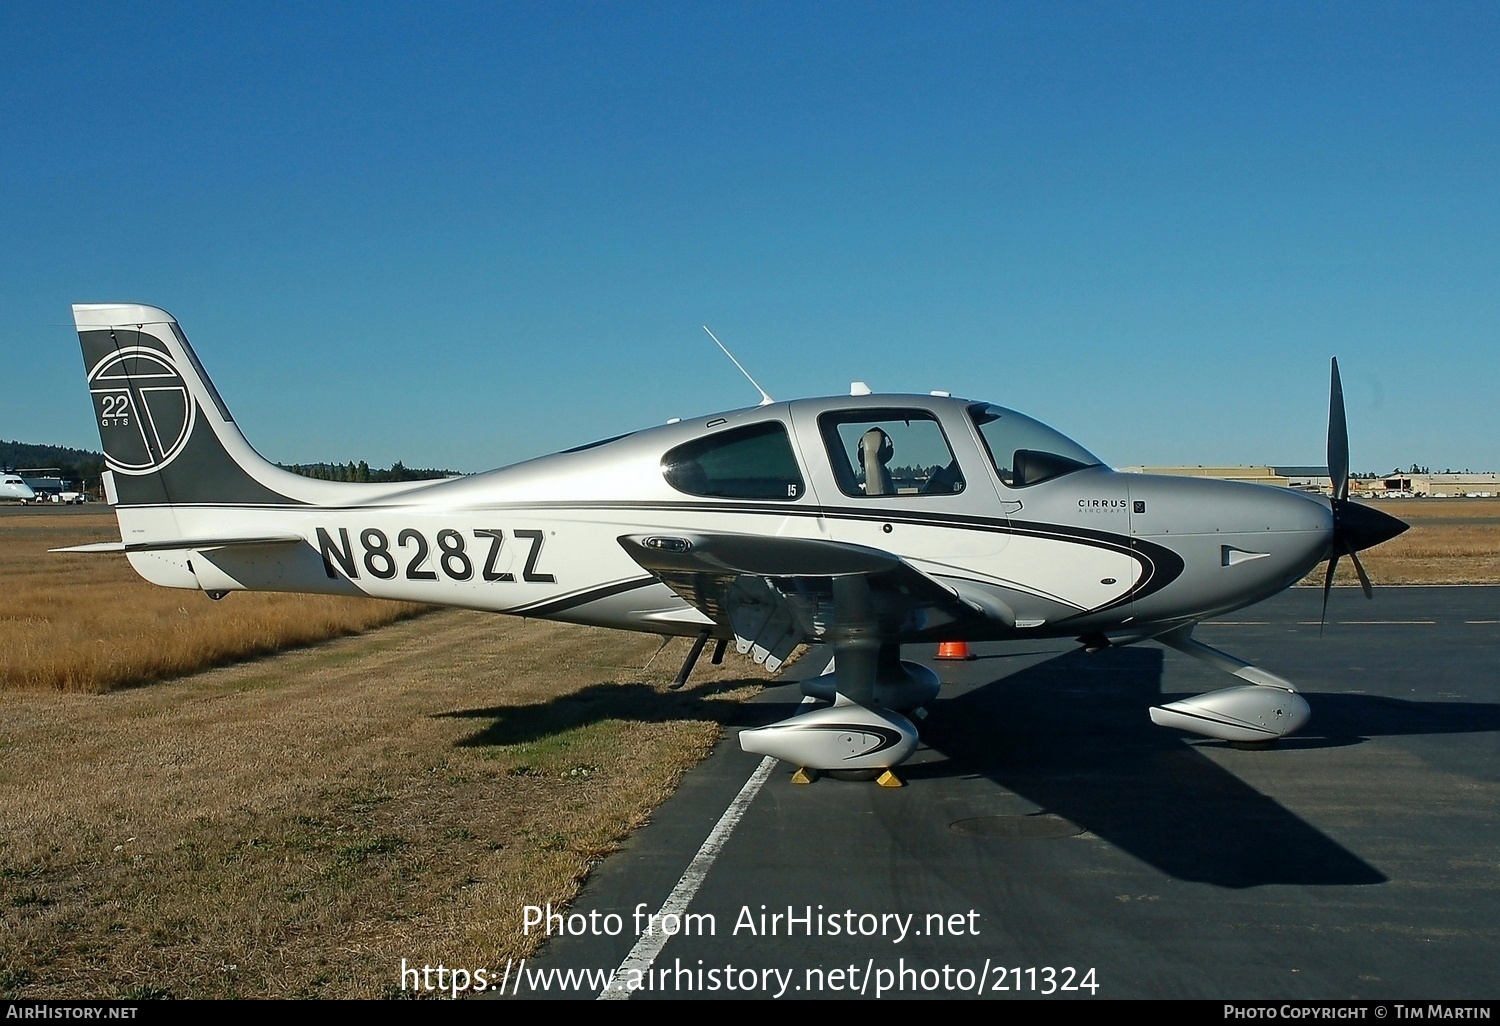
left=662, top=420, right=804, bottom=503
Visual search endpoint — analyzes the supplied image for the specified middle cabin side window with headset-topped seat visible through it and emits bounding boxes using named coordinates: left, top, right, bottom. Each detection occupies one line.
left=818, top=410, right=965, bottom=498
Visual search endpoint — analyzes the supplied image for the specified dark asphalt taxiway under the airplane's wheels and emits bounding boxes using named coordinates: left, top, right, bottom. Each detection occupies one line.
left=507, top=588, right=1500, bottom=999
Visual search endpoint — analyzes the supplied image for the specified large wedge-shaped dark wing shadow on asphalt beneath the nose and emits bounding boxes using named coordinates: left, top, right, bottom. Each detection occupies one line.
left=906, top=648, right=1388, bottom=888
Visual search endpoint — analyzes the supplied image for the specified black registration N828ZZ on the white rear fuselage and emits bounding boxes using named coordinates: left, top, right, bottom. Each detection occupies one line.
left=318, top=528, right=557, bottom=584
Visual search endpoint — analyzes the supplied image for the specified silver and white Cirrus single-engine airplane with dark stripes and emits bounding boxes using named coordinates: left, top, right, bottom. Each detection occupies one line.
left=72, top=305, right=1407, bottom=783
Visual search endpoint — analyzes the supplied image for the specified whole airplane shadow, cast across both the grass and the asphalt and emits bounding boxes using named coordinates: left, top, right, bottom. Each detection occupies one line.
left=440, top=647, right=1500, bottom=888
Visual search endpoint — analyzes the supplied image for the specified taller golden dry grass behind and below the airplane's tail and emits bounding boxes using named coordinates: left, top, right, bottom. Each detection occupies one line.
left=0, top=512, right=425, bottom=692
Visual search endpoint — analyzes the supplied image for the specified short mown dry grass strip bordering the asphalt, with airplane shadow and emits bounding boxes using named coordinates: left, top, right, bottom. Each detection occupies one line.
left=0, top=611, right=759, bottom=998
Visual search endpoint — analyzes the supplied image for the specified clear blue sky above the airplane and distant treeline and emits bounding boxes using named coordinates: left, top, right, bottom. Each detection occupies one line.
left=0, top=3, right=1500, bottom=471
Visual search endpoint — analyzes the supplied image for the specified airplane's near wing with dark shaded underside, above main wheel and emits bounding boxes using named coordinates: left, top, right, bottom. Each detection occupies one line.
left=620, top=531, right=986, bottom=671
